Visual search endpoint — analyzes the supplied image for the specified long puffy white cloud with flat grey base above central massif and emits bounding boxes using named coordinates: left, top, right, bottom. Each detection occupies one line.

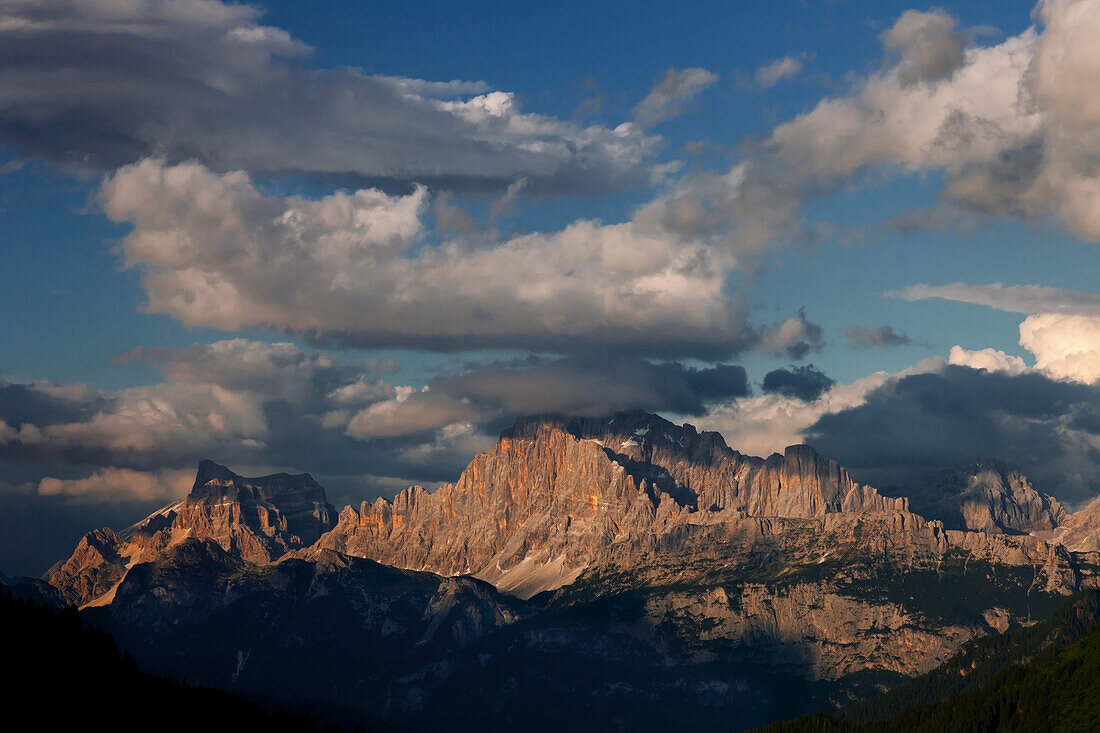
left=101, top=160, right=756, bottom=357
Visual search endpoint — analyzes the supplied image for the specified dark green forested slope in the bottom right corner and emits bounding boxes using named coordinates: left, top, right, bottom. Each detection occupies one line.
left=759, top=591, right=1100, bottom=733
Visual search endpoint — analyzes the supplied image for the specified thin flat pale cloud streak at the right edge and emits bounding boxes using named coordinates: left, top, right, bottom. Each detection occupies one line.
left=887, top=283, right=1100, bottom=316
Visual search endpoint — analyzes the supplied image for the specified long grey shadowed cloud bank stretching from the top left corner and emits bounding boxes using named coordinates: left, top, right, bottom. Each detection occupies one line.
left=0, top=0, right=659, bottom=195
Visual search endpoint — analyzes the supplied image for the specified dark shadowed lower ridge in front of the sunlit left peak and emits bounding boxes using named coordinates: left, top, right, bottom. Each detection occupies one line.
left=84, top=530, right=519, bottom=718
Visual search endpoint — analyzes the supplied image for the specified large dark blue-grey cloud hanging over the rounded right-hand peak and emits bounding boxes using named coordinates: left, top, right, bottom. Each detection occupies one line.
left=806, top=365, right=1100, bottom=503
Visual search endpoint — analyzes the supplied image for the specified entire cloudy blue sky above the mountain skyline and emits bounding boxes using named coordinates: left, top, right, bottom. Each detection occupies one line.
left=0, top=0, right=1100, bottom=573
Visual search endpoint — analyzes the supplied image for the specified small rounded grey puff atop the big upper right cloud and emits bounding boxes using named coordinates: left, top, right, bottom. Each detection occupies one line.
left=882, top=9, right=966, bottom=85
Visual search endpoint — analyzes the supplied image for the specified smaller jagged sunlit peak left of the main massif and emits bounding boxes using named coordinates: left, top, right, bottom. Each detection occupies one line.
left=46, top=461, right=336, bottom=605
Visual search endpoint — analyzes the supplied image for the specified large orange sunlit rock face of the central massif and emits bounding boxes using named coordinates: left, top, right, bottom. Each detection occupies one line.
left=319, top=413, right=908, bottom=598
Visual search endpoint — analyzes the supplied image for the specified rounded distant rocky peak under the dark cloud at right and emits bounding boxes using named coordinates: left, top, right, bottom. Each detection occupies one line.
left=911, top=461, right=1067, bottom=534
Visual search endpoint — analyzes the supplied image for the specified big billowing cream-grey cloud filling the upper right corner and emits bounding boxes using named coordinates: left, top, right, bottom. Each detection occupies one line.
left=746, top=0, right=1100, bottom=240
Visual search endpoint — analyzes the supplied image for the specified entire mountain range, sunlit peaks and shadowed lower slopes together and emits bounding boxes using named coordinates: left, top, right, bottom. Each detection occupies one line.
left=11, top=413, right=1100, bottom=730
